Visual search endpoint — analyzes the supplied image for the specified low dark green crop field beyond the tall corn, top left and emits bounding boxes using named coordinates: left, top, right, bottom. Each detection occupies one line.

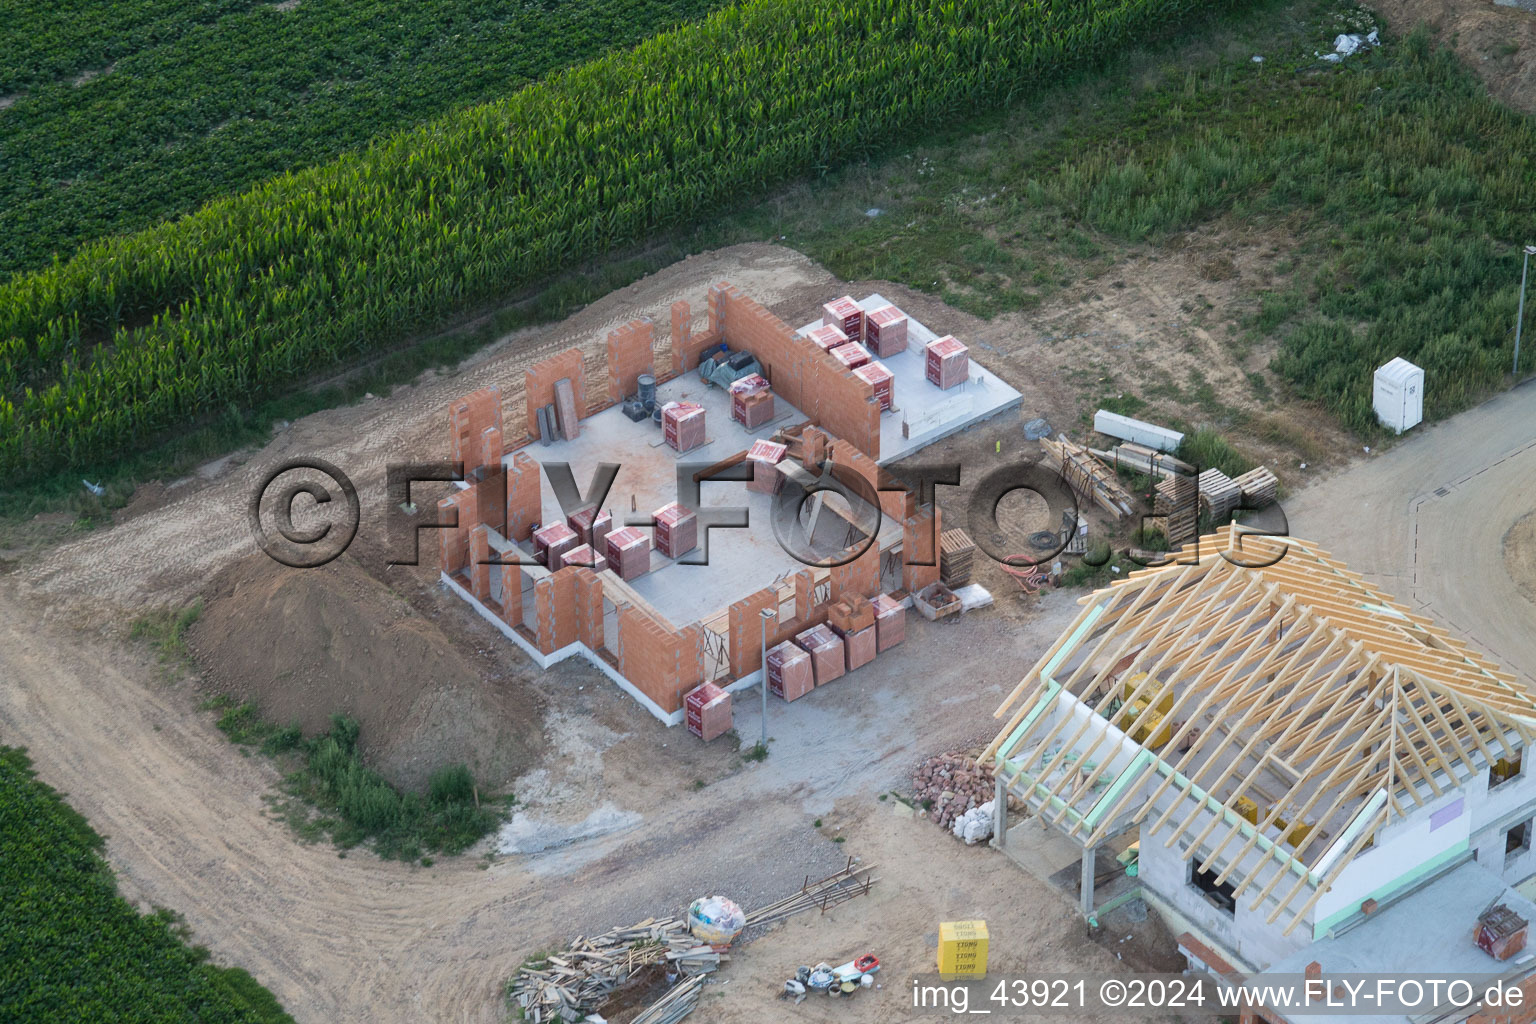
left=0, top=0, right=723, bottom=276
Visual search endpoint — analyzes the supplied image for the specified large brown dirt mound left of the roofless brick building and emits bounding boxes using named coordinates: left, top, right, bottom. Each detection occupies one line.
left=187, top=554, right=544, bottom=789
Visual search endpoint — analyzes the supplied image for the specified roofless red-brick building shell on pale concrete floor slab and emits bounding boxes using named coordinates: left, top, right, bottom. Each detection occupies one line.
left=439, top=282, right=1018, bottom=725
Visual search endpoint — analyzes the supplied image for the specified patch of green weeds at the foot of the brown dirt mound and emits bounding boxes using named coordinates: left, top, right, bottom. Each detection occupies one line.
left=203, top=709, right=500, bottom=866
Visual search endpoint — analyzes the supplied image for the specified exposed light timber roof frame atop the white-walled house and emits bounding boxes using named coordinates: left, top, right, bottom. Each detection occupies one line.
left=983, top=527, right=1536, bottom=933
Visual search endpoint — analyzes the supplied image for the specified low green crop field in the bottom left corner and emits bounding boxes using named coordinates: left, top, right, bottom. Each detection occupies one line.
left=0, top=748, right=293, bottom=1024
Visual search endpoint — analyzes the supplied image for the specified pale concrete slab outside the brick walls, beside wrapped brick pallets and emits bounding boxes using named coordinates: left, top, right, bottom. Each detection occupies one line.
left=799, top=293, right=1023, bottom=465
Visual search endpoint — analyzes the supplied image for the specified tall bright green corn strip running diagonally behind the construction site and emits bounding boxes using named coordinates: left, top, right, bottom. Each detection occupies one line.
left=0, top=0, right=1212, bottom=479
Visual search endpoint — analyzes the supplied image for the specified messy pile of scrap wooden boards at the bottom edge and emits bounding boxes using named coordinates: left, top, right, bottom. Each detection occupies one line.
left=508, top=918, right=720, bottom=1024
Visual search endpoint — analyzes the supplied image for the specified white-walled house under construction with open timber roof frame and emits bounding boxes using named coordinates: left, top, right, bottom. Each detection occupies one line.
left=985, top=527, right=1536, bottom=994
